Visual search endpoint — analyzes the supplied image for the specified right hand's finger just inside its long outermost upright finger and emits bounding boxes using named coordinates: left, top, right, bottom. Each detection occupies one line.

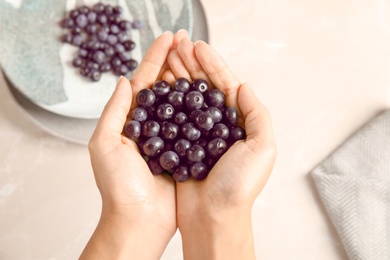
left=177, top=38, right=211, bottom=83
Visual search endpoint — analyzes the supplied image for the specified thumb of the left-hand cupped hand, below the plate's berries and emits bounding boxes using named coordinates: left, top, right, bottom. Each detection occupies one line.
left=93, top=76, right=132, bottom=145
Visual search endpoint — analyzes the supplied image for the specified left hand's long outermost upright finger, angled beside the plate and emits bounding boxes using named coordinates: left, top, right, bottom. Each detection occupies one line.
left=130, top=32, right=173, bottom=103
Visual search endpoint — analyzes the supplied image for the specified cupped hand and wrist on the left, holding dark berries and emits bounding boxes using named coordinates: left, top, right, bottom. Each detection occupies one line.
left=81, top=32, right=177, bottom=259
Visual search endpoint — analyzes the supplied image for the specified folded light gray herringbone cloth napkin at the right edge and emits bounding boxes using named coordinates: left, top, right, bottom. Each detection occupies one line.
left=311, top=110, right=390, bottom=260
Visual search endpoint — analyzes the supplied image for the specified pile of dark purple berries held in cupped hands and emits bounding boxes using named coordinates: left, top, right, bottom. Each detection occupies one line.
left=123, top=78, right=246, bottom=182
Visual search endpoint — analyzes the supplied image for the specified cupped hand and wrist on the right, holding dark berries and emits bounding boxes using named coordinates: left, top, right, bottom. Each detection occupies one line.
left=168, top=31, right=276, bottom=259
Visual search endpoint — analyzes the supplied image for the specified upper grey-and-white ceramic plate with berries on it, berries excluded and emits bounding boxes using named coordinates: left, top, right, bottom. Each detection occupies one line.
left=0, top=0, right=193, bottom=118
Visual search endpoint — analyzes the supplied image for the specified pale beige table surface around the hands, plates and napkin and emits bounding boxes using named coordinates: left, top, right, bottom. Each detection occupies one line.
left=0, top=0, right=390, bottom=260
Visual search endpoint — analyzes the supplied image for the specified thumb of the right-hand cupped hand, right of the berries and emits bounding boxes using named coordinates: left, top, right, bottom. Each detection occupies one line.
left=238, top=83, right=274, bottom=149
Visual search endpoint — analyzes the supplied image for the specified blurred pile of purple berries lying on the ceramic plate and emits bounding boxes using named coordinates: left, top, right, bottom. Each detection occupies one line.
left=61, top=3, right=141, bottom=81
